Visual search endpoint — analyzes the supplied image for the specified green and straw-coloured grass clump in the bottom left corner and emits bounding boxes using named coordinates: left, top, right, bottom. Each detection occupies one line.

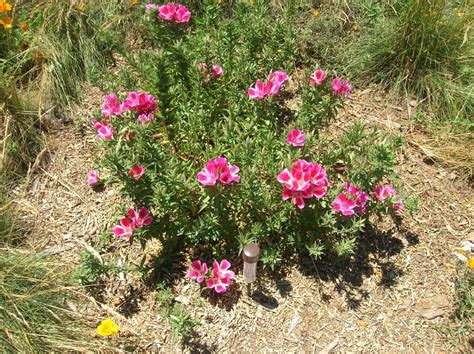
left=0, top=249, right=107, bottom=353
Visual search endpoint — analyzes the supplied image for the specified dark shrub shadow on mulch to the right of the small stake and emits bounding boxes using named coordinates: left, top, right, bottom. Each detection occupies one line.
left=252, top=219, right=419, bottom=310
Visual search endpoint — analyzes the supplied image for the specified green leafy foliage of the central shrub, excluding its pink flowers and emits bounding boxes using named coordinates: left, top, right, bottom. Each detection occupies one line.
left=89, top=2, right=412, bottom=266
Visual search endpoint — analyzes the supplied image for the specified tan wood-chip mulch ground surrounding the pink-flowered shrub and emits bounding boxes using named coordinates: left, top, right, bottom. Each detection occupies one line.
left=15, top=83, right=474, bottom=352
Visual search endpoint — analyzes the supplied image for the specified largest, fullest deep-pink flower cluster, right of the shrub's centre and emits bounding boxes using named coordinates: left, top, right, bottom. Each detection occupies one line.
left=277, top=160, right=329, bottom=209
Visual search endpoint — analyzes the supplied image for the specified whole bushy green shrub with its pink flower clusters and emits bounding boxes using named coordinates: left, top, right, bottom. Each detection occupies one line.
left=87, top=4, right=410, bottom=272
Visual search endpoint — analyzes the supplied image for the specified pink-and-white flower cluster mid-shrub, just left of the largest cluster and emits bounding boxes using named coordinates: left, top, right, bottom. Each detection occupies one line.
left=197, top=156, right=240, bottom=187
